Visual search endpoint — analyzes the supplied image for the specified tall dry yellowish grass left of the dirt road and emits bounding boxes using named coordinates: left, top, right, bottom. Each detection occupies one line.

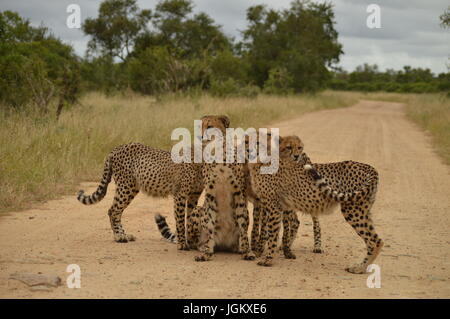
left=0, top=92, right=358, bottom=211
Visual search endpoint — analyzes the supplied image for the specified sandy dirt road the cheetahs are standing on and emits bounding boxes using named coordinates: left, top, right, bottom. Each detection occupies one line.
left=0, top=101, right=450, bottom=298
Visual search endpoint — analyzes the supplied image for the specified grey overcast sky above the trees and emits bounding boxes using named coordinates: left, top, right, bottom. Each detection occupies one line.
left=0, top=0, right=450, bottom=73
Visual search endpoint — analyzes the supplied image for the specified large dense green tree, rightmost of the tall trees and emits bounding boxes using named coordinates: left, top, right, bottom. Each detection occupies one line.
left=241, top=0, right=343, bottom=92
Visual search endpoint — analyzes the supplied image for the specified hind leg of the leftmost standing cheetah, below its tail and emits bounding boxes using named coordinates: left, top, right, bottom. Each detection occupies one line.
left=108, top=182, right=139, bottom=243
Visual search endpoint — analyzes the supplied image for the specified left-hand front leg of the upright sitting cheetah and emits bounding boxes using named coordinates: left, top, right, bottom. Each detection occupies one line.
left=195, top=193, right=218, bottom=261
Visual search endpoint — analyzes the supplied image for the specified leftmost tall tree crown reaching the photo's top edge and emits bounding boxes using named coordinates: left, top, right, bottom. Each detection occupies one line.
left=83, top=0, right=152, bottom=61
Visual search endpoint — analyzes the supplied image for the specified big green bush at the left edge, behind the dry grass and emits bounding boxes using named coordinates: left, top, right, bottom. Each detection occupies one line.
left=0, top=11, right=79, bottom=113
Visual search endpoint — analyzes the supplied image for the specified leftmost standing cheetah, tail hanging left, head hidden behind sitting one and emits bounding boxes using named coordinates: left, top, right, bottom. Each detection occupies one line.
left=78, top=122, right=214, bottom=250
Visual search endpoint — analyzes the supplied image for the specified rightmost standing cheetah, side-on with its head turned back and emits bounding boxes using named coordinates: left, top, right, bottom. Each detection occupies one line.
left=250, top=136, right=383, bottom=274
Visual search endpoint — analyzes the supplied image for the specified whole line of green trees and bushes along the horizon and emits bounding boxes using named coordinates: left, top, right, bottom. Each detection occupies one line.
left=0, top=0, right=449, bottom=115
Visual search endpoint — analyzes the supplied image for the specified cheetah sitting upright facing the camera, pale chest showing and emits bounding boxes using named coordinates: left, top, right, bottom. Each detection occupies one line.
left=195, top=116, right=255, bottom=261
